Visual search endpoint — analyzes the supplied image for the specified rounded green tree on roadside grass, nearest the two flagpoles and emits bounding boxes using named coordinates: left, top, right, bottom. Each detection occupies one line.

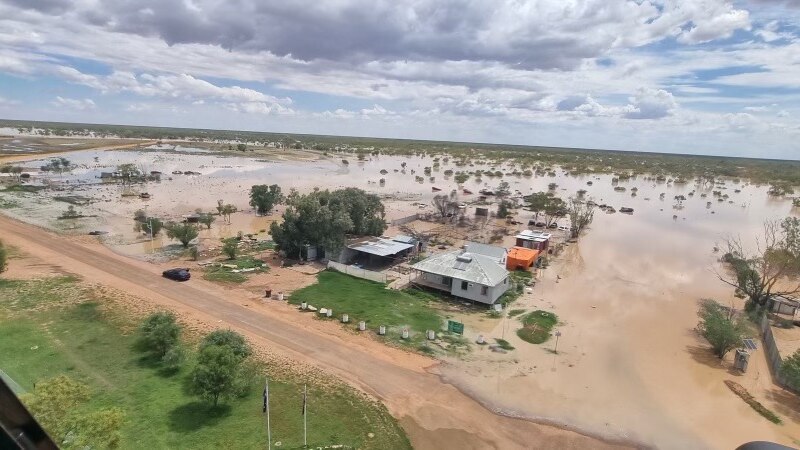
left=190, top=345, right=241, bottom=406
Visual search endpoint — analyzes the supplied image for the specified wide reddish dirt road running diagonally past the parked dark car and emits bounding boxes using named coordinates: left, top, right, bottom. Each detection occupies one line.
left=0, top=217, right=630, bottom=449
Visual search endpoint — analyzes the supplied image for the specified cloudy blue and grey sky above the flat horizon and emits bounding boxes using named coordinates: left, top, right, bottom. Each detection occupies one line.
left=0, top=0, right=800, bottom=159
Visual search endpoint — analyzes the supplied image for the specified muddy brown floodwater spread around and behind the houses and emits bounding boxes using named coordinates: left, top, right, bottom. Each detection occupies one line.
left=5, top=149, right=800, bottom=449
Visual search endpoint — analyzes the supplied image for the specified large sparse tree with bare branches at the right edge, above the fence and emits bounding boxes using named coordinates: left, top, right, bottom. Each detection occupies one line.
left=717, top=217, right=800, bottom=306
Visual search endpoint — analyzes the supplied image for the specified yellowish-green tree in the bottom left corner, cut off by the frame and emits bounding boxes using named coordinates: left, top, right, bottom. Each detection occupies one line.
left=20, top=375, right=123, bottom=449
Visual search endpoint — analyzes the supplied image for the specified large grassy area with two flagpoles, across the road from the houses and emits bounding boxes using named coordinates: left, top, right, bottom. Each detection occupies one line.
left=0, top=277, right=410, bottom=449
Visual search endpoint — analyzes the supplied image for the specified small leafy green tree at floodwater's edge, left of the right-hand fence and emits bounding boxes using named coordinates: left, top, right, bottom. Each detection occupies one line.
left=697, top=299, right=746, bottom=359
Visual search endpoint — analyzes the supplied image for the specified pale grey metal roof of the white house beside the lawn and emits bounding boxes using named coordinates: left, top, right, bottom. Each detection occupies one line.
left=411, top=251, right=508, bottom=286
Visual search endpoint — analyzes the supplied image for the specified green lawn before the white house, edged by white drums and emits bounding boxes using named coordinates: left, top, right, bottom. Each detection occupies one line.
left=289, top=270, right=444, bottom=344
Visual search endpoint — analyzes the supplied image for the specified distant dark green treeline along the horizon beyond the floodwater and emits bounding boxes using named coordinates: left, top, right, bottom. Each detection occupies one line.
left=0, top=120, right=800, bottom=186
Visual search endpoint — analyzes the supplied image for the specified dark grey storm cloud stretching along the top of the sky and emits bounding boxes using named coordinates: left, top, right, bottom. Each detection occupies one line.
left=6, top=0, right=660, bottom=69
